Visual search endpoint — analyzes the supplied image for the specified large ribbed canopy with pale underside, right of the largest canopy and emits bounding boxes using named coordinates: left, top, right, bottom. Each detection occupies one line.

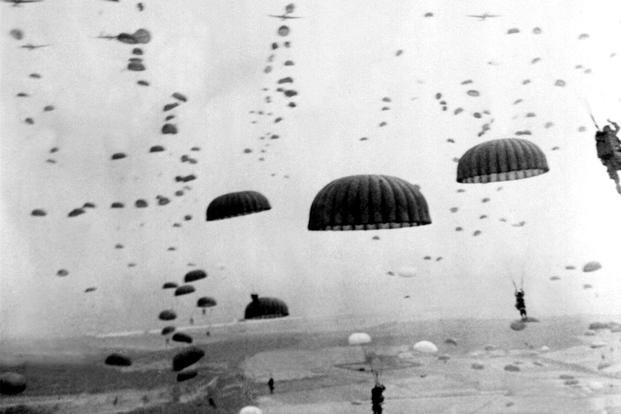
left=457, top=138, right=549, bottom=184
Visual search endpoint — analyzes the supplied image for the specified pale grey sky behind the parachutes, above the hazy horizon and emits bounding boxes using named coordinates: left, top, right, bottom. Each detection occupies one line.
left=0, top=0, right=621, bottom=339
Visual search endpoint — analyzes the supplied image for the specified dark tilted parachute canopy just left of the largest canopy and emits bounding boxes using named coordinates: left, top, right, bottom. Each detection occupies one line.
left=207, top=191, right=272, bottom=221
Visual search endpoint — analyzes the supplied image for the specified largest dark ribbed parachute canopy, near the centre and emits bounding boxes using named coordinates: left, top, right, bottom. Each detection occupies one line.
left=308, top=175, right=431, bottom=230
